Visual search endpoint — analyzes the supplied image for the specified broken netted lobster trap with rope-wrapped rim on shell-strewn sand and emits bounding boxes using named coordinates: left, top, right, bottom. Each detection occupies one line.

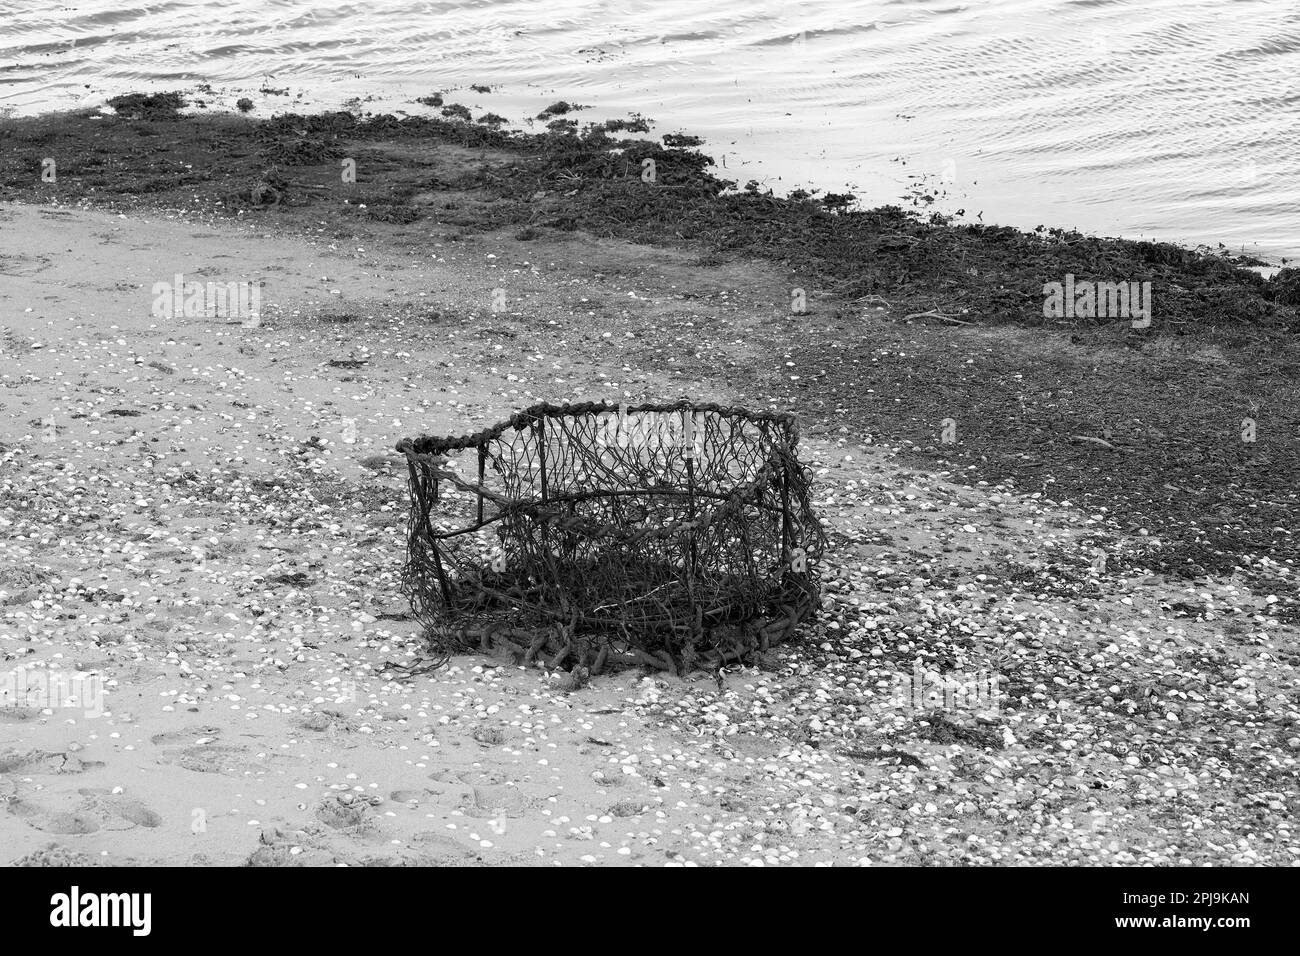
left=398, top=402, right=826, bottom=671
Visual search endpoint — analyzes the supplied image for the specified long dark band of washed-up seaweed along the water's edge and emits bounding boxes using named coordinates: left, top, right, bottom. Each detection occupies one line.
left=0, top=100, right=1300, bottom=345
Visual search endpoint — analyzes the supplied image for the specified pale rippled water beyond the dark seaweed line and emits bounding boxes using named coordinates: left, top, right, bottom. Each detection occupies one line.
left=0, top=0, right=1300, bottom=256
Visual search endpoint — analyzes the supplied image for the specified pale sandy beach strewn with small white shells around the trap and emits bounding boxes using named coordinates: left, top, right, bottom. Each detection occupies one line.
left=0, top=102, right=1300, bottom=866
